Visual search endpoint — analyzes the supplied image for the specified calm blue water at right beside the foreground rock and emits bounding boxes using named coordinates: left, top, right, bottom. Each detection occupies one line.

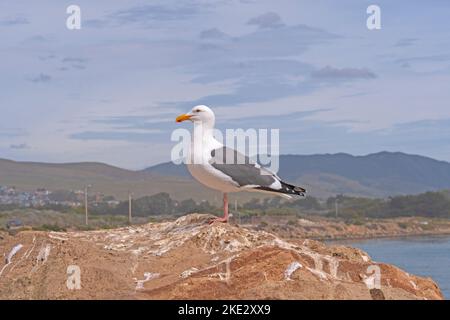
left=328, top=236, right=450, bottom=300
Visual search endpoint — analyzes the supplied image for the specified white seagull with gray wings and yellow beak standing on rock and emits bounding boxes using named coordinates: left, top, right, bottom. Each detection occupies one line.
left=176, top=105, right=306, bottom=223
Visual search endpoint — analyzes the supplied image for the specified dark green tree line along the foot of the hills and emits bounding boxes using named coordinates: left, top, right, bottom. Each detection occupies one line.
left=0, top=191, right=450, bottom=219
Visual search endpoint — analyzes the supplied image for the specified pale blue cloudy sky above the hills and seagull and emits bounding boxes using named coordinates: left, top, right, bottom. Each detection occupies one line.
left=0, top=0, right=450, bottom=169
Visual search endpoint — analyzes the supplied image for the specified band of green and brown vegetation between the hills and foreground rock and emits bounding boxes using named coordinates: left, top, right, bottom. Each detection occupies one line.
left=0, top=191, right=450, bottom=231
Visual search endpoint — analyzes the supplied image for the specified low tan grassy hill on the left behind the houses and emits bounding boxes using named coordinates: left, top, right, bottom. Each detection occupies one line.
left=0, top=159, right=256, bottom=203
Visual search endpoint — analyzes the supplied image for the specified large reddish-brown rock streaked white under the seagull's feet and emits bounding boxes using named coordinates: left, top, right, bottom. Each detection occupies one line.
left=0, top=214, right=443, bottom=300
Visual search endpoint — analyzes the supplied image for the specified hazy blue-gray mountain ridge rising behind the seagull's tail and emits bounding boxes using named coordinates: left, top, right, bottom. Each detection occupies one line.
left=144, top=152, right=450, bottom=197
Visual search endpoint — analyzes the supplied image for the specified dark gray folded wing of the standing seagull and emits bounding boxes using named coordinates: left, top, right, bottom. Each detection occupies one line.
left=210, top=147, right=278, bottom=187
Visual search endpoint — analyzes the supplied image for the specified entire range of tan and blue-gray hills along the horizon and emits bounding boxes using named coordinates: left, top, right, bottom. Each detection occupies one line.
left=0, top=152, right=450, bottom=202
